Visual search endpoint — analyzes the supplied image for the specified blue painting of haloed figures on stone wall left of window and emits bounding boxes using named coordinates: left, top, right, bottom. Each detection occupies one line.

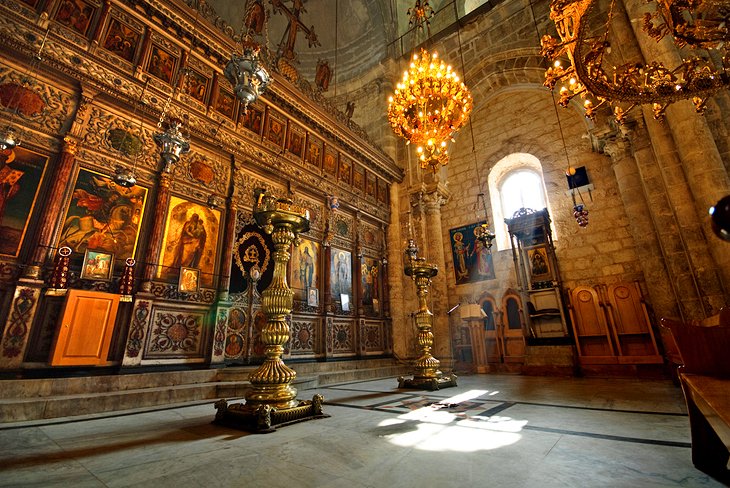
left=449, top=222, right=495, bottom=285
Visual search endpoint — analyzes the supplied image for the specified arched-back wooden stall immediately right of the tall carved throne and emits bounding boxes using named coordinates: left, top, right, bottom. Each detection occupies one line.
left=568, top=286, right=618, bottom=364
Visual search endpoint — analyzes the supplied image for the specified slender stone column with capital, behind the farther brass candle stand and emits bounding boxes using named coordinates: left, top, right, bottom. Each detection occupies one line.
left=422, top=183, right=454, bottom=370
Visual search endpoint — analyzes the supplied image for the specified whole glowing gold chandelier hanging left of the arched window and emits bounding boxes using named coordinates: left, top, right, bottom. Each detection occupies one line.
left=388, top=49, right=473, bottom=172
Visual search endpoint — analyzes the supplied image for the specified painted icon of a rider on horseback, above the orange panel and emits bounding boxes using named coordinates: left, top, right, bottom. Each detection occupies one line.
left=58, top=168, right=147, bottom=258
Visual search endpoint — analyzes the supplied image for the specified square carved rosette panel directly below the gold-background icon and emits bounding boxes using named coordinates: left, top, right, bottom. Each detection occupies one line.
left=144, top=306, right=207, bottom=359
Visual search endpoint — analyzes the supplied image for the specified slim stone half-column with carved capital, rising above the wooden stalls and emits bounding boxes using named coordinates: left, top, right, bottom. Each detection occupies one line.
left=604, top=124, right=676, bottom=317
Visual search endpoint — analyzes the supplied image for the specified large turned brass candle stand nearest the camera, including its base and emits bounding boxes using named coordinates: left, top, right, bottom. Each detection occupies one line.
left=215, top=191, right=328, bottom=433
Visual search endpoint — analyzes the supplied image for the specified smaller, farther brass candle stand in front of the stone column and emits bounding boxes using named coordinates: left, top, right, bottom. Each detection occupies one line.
left=398, top=239, right=456, bottom=391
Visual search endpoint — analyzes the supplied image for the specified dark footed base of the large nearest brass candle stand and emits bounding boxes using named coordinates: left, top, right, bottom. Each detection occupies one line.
left=213, top=394, right=329, bottom=434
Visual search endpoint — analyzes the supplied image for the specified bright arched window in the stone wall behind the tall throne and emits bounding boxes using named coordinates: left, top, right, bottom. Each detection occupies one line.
left=489, top=153, right=557, bottom=249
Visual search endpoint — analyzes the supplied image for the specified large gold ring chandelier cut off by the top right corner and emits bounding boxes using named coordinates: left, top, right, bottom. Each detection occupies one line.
left=541, top=0, right=730, bottom=123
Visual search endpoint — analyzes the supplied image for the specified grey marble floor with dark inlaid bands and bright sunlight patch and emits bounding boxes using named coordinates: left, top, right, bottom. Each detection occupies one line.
left=0, top=375, right=722, bottom=488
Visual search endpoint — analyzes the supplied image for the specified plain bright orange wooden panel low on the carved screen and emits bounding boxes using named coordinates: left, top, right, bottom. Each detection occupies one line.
left=51, top=290, right=119, bottom=366
